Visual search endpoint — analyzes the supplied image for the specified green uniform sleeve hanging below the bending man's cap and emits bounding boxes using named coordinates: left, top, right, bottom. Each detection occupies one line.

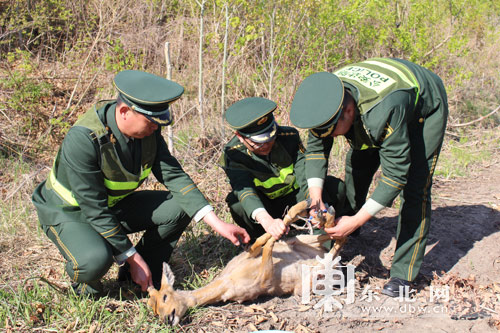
left=305, top=131, right=333, bottom=179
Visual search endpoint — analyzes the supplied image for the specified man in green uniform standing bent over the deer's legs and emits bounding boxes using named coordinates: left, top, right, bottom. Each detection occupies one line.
left=290, top=58, right=448, bottom=297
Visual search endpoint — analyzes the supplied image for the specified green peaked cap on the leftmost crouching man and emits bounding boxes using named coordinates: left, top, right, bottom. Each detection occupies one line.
left=113, top=70, right=184, bottom=125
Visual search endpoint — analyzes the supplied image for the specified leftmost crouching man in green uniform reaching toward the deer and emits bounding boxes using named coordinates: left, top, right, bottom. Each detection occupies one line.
left=33, top=70, right=250, bottom=295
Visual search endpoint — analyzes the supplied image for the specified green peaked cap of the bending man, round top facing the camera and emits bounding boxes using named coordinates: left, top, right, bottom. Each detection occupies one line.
left=290, top=72, right=344, bottom=129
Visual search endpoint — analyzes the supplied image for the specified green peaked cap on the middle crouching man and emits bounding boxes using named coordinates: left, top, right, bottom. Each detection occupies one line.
left=224, top=97, right=277, bottom=137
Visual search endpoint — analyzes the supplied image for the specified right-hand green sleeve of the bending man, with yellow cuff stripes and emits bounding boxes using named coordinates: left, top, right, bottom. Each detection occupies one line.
left=371, top=93, right=411, bottom=207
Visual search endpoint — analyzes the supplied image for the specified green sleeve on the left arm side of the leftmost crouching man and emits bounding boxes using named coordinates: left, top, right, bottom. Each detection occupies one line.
left=58, top=127, right=133, bottom=255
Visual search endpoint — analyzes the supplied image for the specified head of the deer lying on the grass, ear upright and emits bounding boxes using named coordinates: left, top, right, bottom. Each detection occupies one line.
left=148, top=263, right=188, bottom=326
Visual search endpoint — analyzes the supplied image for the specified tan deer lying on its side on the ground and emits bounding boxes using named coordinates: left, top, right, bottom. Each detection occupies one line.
left=148, top=201, right=347, bottom=326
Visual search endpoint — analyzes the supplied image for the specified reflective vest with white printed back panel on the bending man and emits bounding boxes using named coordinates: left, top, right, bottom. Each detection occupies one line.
left=334, top=58, right=420, bottom=149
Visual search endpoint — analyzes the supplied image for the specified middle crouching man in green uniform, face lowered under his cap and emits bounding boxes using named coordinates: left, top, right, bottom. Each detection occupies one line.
left=223, top=97, right=345, bottom=239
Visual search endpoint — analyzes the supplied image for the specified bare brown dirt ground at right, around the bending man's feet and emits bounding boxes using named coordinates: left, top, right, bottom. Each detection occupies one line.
left=187, top=161, right=500, bottom=332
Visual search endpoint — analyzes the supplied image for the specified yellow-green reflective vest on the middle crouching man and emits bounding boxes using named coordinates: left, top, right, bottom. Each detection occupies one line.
left=253, top=164, right=299, bottom=199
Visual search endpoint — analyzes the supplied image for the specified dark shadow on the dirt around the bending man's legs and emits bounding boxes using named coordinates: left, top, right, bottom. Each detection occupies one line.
left=341, top=205, right=500, bottom=282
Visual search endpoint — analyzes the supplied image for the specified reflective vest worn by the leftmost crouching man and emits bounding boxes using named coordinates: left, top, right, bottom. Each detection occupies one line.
left=46, top=106, right=156, bottom=207
